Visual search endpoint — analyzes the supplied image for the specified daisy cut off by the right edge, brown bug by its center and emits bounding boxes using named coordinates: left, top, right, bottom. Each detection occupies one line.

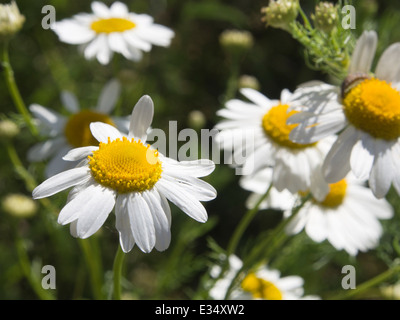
left=288, top=31, right=400, bottom=198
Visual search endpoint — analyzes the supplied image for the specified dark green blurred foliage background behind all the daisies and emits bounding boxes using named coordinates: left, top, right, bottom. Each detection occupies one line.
left=0, top=0, right=400, bottom=299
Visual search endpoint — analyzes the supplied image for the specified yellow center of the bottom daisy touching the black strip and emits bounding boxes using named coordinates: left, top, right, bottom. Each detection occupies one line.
left=241, top=273, right=282, bottom=300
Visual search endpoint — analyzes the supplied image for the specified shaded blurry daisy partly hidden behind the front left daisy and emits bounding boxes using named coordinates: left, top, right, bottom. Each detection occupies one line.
left=28, top=79, right=129, bottom=177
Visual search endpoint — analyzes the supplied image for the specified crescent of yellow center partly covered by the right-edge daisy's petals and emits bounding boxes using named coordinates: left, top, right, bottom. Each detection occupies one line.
left=262, top=104, right=316, bottom=149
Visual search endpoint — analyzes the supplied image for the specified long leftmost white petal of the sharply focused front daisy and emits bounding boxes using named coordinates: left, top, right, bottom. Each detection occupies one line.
left=32, top=167, right=90, bottom=199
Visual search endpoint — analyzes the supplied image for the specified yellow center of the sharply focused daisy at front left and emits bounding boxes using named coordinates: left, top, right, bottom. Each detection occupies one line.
left=89, top=137, right=162, bottom=193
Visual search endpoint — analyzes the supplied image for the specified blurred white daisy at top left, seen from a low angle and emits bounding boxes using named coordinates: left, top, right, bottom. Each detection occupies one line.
left=52, top=1, right=174, bottom=65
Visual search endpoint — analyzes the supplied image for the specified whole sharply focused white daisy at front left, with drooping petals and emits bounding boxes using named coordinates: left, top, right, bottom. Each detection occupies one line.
left=33, top=96, right=216, bottom=252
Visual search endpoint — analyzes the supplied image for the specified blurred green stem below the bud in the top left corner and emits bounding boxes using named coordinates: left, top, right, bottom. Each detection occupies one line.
left=2, top=42, right=38, bottom=137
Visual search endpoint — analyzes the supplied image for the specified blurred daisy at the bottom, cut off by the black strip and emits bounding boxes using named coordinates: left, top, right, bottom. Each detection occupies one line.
left=209, top=255, right=319, bottom=300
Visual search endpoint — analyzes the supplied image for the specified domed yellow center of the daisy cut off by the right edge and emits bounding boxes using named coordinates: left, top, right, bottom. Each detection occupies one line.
left=343, top=78, right=400, bottom=140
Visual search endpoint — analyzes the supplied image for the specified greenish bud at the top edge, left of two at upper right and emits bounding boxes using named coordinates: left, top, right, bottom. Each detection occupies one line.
left=261, top=0, right=300, bottom=31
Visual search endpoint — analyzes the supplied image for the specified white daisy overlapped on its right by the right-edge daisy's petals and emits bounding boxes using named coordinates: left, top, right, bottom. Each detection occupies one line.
left=216, top=88, right=332, bottom=193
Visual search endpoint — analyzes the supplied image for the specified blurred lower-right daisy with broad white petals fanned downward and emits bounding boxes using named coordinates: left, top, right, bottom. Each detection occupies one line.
left=285, top=173, right=393, bottom=256
